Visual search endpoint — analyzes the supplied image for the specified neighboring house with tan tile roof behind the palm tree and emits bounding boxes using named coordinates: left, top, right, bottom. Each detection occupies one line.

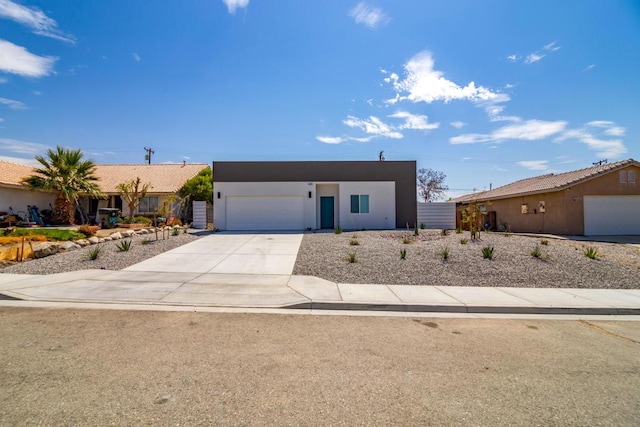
left=0, top=161, right=210, bottom=226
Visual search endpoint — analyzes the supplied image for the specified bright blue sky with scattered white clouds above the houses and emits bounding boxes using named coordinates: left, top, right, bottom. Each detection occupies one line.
left=0, top=0, right=640, bottom=196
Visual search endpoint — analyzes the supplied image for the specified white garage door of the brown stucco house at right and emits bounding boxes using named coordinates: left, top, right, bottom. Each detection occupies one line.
left=584, top=196, right=640, bottom=236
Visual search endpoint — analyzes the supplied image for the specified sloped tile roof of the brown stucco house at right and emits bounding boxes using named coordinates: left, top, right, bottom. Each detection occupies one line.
left=451, top=159, right=640, bottom=202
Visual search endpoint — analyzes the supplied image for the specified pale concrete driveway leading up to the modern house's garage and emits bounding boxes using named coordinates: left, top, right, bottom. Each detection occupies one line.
left=125, top=232, right=302, bottom=275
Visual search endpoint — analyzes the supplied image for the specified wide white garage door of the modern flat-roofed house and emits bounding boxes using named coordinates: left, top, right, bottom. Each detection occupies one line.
left=226, top=196, right=304, bottom=230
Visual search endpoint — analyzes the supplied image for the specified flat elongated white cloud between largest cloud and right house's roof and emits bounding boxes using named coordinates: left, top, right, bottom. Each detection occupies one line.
left=449, top=120, right=567, bottom=144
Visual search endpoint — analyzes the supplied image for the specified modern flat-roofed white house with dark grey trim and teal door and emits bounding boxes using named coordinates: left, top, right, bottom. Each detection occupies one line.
left=213, top=161, right=417, bottom=230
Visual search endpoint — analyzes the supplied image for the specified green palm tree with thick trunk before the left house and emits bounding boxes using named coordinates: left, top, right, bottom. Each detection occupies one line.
left=22, top=146, right=104, bottom=224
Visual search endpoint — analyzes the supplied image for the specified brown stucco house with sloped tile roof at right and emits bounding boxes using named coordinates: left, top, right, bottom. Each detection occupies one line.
left=452, top=159, right=640, bottom=236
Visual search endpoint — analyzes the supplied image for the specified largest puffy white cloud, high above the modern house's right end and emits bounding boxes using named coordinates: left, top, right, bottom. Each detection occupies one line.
left=385, top=51, right=509, bottom=104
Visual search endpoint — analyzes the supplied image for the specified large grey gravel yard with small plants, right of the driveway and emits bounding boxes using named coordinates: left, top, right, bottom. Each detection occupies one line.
left=294, top=230, right=640, bottom=289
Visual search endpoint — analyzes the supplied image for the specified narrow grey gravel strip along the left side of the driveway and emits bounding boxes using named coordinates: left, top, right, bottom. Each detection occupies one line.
left=0, top=232, right=200, bottom=274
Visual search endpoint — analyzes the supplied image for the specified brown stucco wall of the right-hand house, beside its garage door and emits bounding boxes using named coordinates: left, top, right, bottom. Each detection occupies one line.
left=457, top=166, right=640, bottom=235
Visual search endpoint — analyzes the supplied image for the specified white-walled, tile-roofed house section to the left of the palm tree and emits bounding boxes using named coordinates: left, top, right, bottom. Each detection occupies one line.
left=0, top=160, right=55, bottom=216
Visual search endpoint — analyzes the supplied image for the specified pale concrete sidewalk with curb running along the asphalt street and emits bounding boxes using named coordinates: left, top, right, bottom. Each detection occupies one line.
left=0, top=270, right=640, bottom=315
